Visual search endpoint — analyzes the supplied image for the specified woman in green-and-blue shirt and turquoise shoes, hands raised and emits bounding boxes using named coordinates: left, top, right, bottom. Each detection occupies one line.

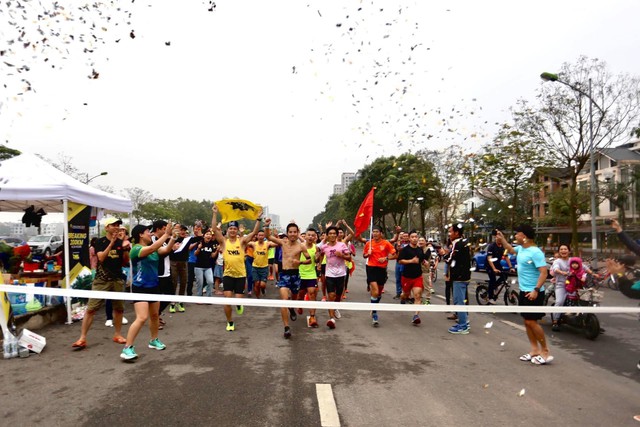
left=120, top=224, right=172, bottom=360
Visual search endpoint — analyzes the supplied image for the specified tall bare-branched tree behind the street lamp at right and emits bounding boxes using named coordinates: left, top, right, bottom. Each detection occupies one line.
left=514, top=56, right=640, bottom=248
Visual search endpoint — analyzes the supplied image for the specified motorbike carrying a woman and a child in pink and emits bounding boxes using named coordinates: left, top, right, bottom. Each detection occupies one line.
left=544, top=285, right=604, bottom=340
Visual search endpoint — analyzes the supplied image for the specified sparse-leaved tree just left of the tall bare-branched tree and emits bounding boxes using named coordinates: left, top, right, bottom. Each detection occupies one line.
left=465, top=124, right=548, bottom=230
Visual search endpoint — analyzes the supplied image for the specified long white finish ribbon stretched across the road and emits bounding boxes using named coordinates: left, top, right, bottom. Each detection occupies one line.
left=0, top=285, right=640, bottom=314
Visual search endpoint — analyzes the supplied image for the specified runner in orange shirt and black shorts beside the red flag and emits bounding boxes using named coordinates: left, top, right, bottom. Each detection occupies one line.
left=362, top=225, right=396, bottom=326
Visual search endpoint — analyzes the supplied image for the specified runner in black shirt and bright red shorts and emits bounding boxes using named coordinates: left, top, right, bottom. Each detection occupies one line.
left=398, top=230, right=428, bottom=326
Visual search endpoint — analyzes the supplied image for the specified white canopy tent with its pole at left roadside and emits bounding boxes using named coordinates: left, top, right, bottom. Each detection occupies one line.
left=0, top=154, right=133, bottom=323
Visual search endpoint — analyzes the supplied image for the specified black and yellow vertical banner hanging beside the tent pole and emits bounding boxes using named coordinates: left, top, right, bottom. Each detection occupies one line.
left=63, top=202, right=91, bottom=283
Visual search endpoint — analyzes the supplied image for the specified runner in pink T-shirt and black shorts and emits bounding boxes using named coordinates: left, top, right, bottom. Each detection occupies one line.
left=318, top=226, right=351, bottom=329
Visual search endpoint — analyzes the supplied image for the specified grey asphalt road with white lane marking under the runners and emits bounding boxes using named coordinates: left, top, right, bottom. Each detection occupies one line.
left=0, top=260, right=640, bottom=426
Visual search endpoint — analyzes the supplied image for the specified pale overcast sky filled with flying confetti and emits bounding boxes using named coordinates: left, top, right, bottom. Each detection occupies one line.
left=0, top=0, right=640, bottom=225
